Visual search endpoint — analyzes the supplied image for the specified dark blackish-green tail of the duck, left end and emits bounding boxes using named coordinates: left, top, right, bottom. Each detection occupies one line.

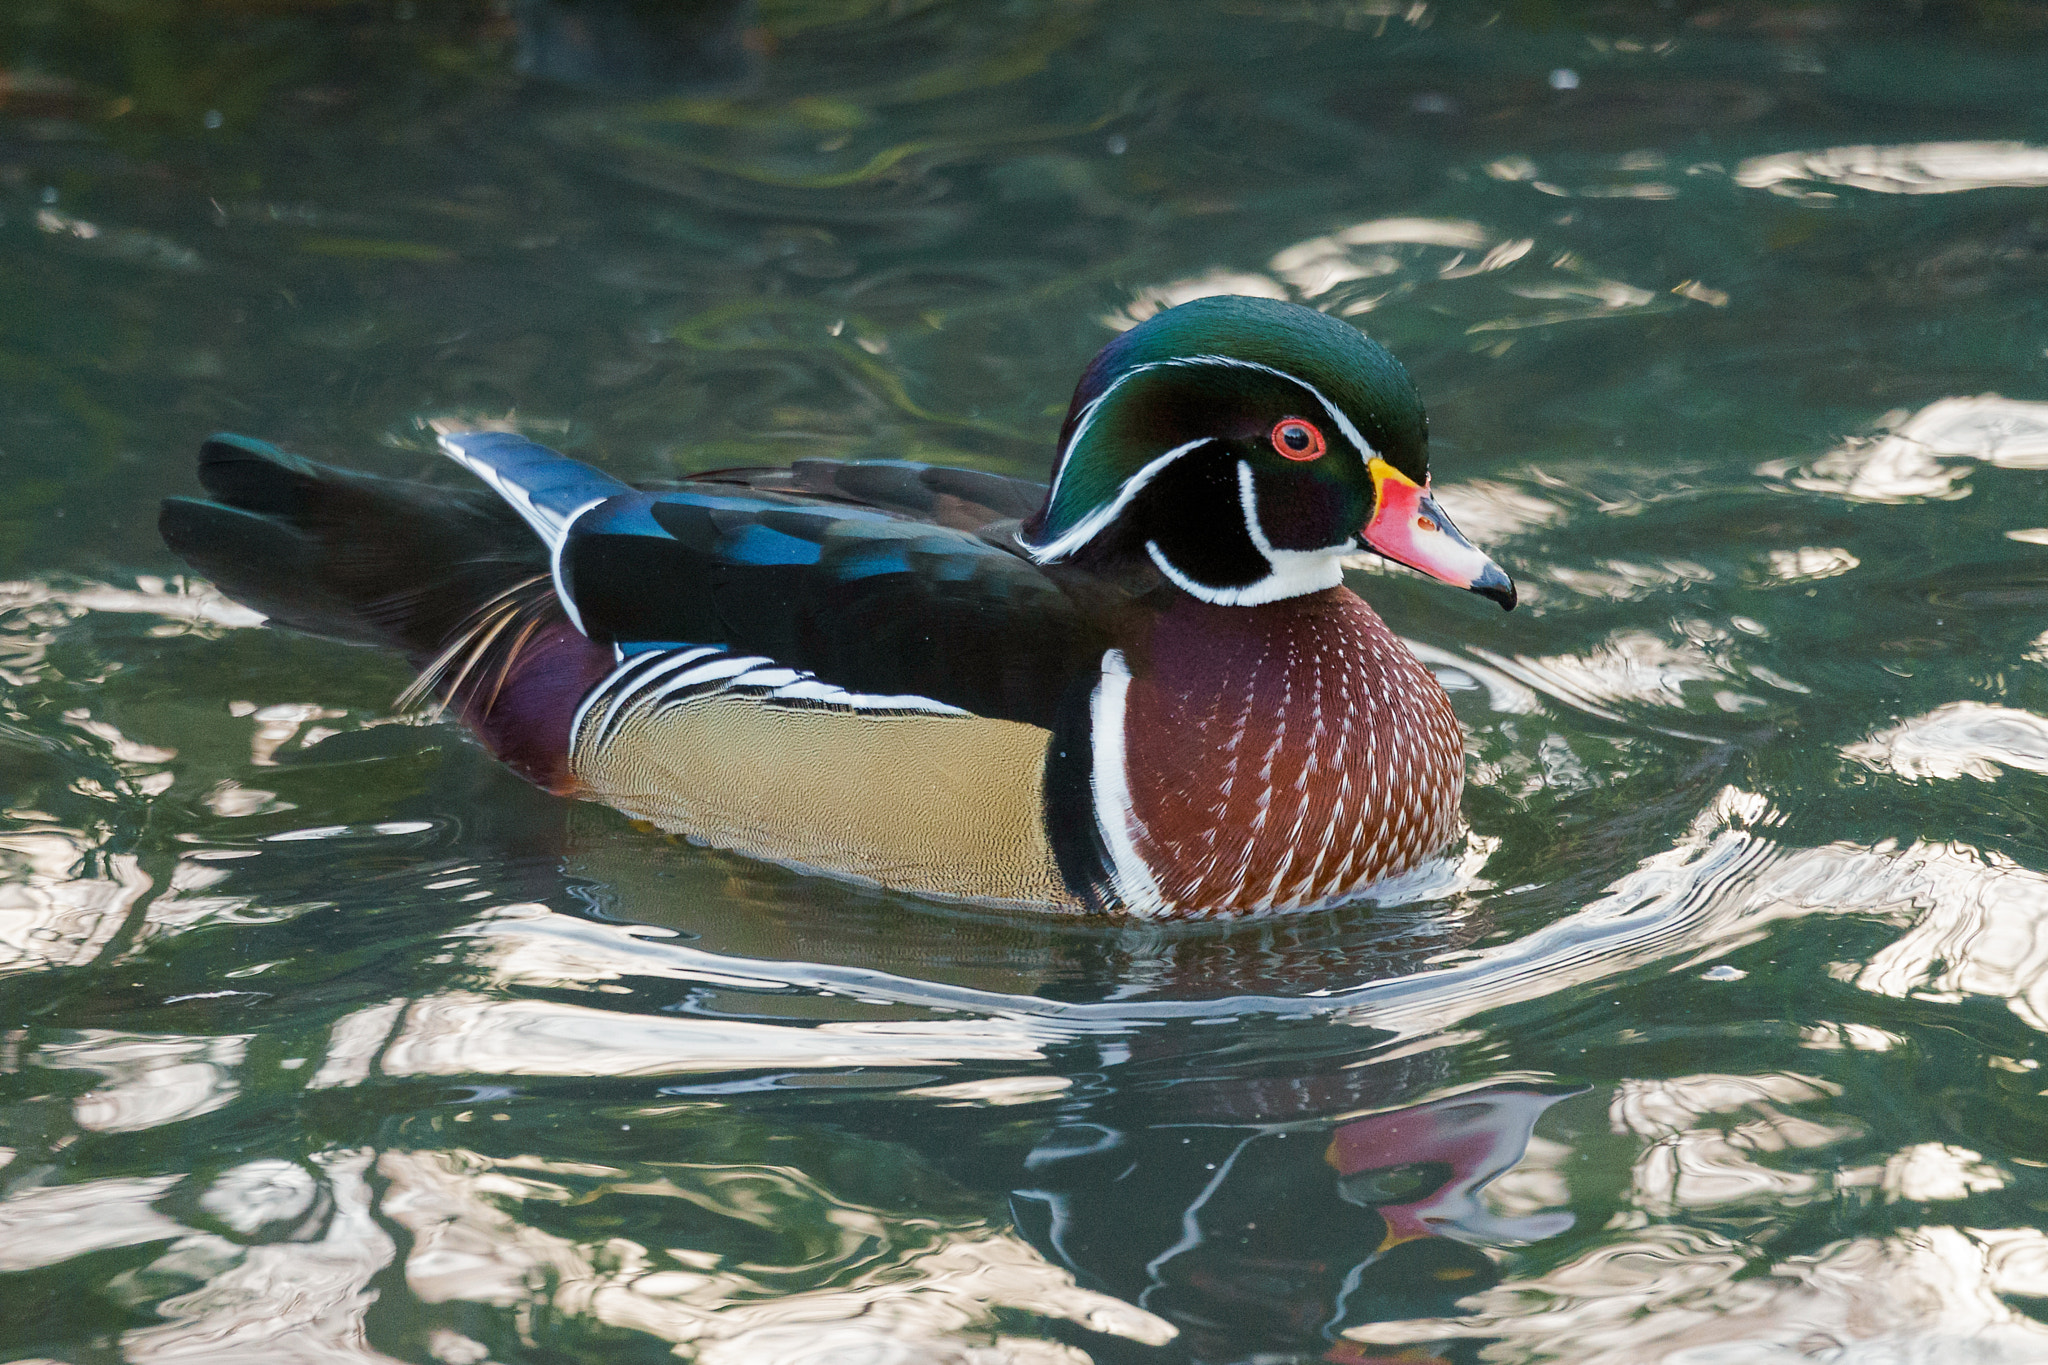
left=158, top=436, right=549, bottom=665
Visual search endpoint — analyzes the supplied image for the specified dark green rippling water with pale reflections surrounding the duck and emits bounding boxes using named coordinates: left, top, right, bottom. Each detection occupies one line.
left=0, top=0, right=2048, bottom=1365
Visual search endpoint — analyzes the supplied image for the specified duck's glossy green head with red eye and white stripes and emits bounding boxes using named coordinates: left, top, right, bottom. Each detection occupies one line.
left=1020, top=297, right=1516, bottom=610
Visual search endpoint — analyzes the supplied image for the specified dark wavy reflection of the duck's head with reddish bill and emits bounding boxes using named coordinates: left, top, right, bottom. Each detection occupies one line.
left=1010, top=1068, right=1579, bottom=1365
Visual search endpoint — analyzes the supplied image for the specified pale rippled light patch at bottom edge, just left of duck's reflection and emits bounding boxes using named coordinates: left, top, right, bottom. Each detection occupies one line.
left=379, top=1150, right=1174, bottom=1365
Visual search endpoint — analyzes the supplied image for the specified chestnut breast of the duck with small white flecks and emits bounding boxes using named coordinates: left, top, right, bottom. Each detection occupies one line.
left=1122, top=587, right=1464, bottom=915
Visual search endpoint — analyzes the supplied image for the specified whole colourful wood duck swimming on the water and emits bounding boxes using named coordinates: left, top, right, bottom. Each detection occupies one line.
left=160, top=297, right=1516, bottom=919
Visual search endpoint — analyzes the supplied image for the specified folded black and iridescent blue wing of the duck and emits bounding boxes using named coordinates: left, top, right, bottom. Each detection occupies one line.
left=442, top=434, right=1104, bottom=724
